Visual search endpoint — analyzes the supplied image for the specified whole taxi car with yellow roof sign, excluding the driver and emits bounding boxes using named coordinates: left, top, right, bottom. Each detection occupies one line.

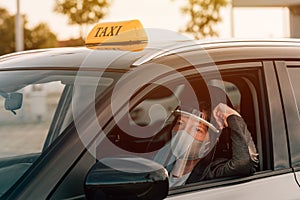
left=0, top=20, right=300, bottom=200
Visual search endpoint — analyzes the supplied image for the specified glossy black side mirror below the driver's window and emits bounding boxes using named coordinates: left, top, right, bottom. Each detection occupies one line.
left=84, top=157, right=169, bottom=200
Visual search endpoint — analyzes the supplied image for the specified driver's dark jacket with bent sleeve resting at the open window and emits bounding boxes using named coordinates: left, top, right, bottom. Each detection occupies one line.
left=187, top=115, right=258, bottom=183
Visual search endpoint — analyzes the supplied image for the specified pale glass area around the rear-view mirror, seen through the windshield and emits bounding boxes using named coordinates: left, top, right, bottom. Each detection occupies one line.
left=0, top=81, right=64, bottom=157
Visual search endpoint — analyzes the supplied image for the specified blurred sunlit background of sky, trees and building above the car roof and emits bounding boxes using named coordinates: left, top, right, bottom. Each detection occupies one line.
left=0, top=0, right=300, bottom=55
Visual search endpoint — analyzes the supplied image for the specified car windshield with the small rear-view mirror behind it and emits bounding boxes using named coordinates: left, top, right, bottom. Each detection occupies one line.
left=0, top=70, right=118, bottom=196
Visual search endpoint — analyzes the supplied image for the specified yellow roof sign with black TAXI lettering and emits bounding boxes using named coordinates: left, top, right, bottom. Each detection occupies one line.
left=85, top=20, right=148, bottom=51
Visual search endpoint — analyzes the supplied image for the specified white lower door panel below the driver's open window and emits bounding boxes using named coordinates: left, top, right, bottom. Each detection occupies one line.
left=167, top=173, right=300, bottom=200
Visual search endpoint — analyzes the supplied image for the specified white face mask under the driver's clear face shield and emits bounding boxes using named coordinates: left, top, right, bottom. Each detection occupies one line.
left=171, top=130, right=194, bottom=158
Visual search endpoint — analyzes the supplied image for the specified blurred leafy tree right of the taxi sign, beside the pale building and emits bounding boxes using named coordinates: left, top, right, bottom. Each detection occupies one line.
left=181, top=0, right=227, bottom=39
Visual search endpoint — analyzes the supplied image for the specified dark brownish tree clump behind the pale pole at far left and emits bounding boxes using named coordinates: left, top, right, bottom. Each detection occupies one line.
left=0, top=8, right=57, bottom=55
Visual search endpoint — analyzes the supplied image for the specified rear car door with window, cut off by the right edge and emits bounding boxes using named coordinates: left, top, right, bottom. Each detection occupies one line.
left=276, top=61, right=300, bottom=188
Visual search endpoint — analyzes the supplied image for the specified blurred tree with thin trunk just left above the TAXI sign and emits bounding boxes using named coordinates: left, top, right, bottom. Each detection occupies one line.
left=54, top=0, right=111, bottom=38
